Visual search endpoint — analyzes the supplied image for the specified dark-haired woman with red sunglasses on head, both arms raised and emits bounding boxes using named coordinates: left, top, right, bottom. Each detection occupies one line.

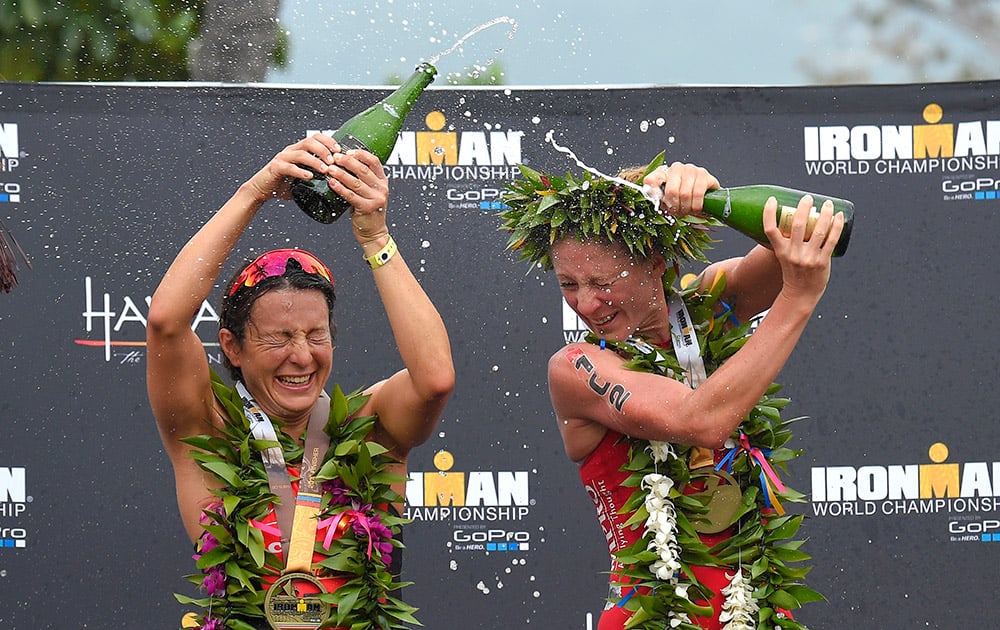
left=147, top=134, right=455, bottom=630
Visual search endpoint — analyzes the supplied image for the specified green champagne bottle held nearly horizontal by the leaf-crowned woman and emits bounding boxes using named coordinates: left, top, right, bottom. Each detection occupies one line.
left=703, top=184, right=854, bottom=256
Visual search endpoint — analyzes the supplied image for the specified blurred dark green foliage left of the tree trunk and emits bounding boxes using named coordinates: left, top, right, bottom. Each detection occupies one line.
left=0, top=0, right=204, bottom=81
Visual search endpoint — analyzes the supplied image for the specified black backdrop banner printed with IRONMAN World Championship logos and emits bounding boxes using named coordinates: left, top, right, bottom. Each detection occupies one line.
left=0, top=82, right=1000, bottom=630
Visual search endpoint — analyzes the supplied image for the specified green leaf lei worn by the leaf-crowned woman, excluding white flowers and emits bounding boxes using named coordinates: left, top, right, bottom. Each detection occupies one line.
left=587, top=271, right=825, bottom=630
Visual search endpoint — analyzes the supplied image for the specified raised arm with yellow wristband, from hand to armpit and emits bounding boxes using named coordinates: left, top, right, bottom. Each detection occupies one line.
left=330, top=151, right=455, bottom=458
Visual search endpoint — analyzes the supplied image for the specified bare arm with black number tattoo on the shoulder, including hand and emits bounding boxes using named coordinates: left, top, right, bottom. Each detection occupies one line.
left=549, top=197, right=843, bottom=460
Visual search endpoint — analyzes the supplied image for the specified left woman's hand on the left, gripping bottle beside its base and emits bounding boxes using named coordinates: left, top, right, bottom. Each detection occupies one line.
left=247, top=133, right=340, bottom=202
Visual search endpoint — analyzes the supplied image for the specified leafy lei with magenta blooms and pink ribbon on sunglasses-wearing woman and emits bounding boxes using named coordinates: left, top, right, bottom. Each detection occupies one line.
left=175, top=372, right=419, bottom=630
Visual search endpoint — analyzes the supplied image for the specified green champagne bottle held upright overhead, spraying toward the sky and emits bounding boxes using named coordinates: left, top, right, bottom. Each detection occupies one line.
left=292, top=63, right=437, bottom=223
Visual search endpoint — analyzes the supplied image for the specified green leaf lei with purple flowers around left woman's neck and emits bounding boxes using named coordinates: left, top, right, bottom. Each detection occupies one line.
left=174, top=372, right=419, bottom=630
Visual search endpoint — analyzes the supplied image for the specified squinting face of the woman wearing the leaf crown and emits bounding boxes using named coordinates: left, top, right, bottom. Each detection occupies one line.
left=551, top=238, right=670, bottom=342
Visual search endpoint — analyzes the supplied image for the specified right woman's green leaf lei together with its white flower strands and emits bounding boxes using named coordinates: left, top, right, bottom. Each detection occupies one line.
left=587, top=271, right=824, bottom=630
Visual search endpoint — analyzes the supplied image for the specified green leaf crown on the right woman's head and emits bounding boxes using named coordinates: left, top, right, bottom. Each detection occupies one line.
left=500, top=153, right=717, bottom=269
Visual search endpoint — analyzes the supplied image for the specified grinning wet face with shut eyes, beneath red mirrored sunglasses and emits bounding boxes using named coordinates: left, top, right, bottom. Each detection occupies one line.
left=219, top=289, right=333, bottom=426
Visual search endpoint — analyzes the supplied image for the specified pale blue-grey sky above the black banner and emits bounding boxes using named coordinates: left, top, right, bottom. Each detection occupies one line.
left=268, top=0, right=868, bottom=86
